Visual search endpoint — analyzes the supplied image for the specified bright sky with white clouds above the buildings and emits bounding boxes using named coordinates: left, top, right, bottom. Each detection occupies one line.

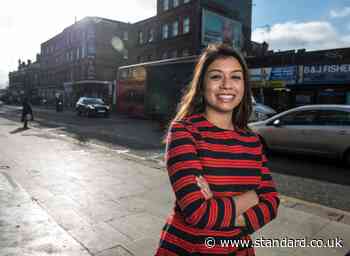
left=0, top=0, right=350, bottom=89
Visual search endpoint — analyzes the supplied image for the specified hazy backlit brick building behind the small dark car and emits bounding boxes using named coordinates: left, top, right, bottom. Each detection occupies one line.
left=39, top=17, right=130, bottom=104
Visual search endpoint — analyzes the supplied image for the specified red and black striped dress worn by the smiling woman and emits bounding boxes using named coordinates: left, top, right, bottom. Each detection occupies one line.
left=156, top=114, right=279, bottom=256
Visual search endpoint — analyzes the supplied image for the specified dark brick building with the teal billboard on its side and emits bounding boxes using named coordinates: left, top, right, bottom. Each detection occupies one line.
left=130, top=0, right=252, bottom=63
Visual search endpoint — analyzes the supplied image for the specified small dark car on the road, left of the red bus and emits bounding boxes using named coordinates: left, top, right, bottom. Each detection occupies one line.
left=75, top=97, right=109, bottom=117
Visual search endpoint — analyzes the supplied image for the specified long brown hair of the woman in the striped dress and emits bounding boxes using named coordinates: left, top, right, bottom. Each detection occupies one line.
left=171, top=44, right=252, bottom=130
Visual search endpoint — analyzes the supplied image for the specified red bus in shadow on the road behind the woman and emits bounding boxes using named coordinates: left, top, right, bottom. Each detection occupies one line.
left=116, top=56, right=196, bottom=120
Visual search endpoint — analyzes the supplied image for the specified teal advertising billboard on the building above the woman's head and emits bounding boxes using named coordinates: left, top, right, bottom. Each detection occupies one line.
left=202, top=9, right=243, bottom=49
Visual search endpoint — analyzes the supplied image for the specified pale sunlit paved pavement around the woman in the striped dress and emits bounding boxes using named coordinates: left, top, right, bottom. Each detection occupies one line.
left=0, top=104, right=350, bottom=256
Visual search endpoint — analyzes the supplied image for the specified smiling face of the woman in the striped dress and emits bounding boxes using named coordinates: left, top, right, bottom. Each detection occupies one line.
left=204, top=57, right=244, bottom=114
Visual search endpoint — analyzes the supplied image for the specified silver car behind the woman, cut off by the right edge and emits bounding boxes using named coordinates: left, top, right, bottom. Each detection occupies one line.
left=249, top=105, right=350, bottom=165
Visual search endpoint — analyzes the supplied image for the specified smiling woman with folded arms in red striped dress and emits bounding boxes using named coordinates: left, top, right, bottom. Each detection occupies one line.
left=156, top=44, right=279, bottom=256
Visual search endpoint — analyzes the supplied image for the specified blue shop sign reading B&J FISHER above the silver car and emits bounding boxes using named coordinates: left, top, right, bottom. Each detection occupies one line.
left=301, top=64, right=350, bottom=84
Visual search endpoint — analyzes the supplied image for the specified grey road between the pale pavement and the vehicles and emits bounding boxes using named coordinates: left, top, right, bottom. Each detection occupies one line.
left=0, top=106, right=350, bottom=211
